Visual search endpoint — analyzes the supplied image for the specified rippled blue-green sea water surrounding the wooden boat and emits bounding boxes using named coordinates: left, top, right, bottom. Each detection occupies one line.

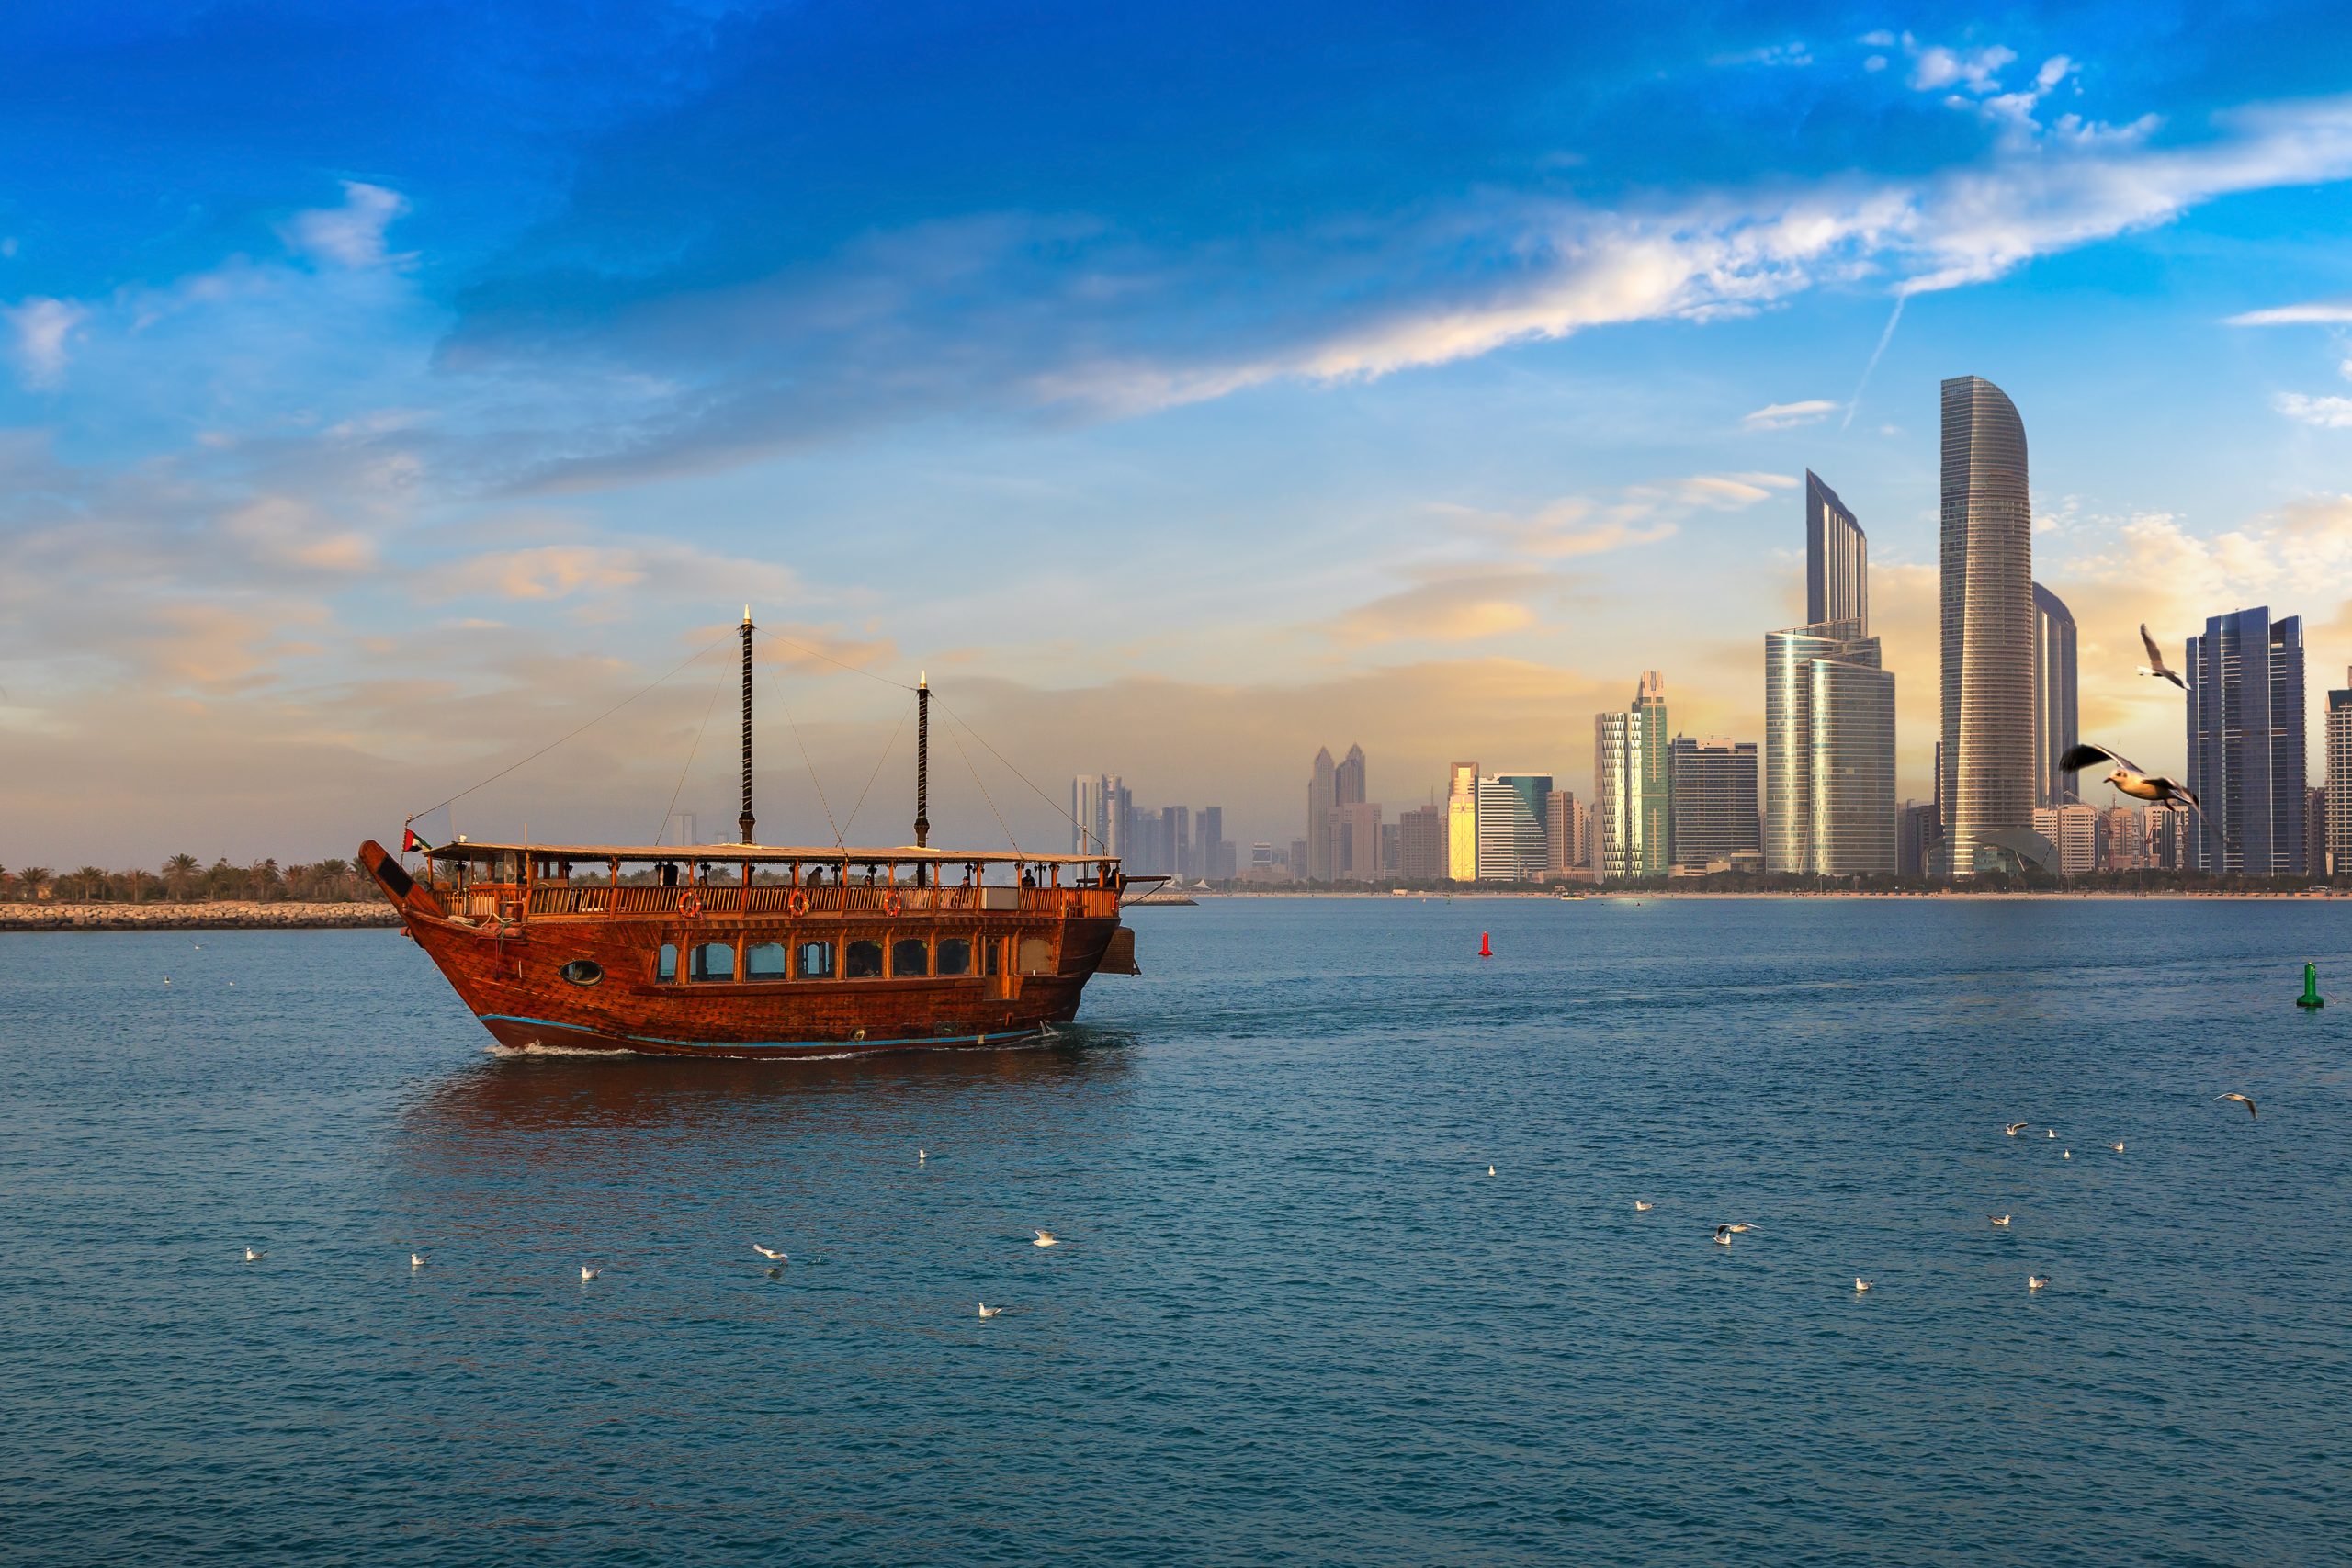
left=0, top=898, right=2352, bottom=1563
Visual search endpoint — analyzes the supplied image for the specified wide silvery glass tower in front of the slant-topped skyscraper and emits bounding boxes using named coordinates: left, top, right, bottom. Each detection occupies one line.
left=1764, top=621, right=1900, bottom=877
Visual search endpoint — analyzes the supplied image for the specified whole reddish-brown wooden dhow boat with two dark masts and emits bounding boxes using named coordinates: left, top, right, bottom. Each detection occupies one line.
left=360, top=611, right=1136, bottom=1058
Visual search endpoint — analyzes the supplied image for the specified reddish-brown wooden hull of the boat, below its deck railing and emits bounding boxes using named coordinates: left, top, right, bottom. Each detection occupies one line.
left=360, top=844, right=1120, bottom=1058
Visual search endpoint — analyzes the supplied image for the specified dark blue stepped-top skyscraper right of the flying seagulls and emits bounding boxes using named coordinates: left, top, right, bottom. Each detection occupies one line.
left=2183, top=604, right=2305, bottom=877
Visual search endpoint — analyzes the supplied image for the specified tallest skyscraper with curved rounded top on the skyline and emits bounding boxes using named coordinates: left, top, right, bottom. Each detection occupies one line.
left=1938, top=376, right=2040, bottom=877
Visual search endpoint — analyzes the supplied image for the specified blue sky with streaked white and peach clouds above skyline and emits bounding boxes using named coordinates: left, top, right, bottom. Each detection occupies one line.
left=0, top=3, right=2352, bottom=863
